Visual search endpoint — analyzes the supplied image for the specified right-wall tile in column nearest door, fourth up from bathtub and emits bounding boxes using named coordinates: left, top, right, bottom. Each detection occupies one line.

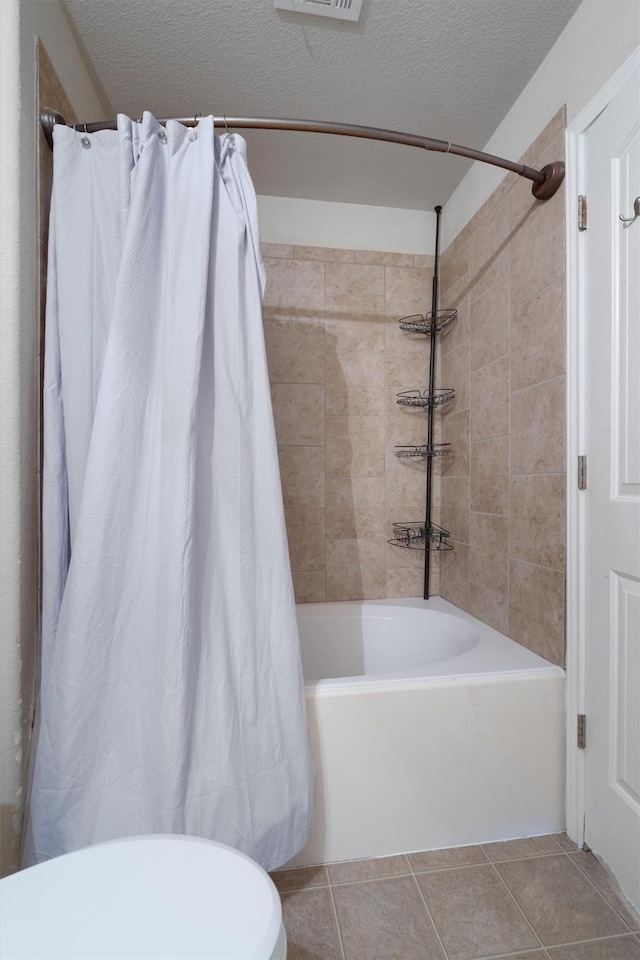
left=511, top=277, right=564, bottom=390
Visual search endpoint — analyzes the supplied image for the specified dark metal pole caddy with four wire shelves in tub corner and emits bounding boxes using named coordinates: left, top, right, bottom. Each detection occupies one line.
left=389, top=207, right=458, bottom=600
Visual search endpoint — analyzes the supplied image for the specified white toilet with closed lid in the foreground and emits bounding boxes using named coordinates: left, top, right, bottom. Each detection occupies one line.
left=0, top=835, right=287, bottom=960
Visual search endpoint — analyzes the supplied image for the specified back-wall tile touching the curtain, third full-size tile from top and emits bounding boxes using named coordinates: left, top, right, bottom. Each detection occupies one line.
left=271, top=383, right=324, bottom=447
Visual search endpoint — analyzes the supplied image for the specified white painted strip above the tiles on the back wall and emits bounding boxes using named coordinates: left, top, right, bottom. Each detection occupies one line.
left=258, top=196, right=436, bottom=254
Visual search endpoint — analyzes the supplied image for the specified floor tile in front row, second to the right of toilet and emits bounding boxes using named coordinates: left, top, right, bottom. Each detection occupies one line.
left=333, top=877, right=444, bottom=960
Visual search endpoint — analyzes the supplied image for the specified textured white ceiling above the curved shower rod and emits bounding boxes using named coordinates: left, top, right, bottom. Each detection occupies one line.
left=67, top=0, right=580, bottom=209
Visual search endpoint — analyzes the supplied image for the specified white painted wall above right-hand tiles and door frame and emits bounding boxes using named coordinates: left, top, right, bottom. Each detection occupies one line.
left=442, top=0, right=640, bottom=250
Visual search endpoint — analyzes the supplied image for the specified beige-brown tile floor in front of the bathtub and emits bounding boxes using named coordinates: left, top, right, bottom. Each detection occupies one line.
left=272, top=835, right=640, bottom=960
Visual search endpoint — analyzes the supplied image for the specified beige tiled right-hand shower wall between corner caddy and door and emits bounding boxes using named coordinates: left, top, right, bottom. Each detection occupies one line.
left=440, top=111, right=565, bottom=664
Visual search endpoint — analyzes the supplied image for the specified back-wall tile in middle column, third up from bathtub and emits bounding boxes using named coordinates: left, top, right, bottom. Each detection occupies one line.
left=326, top=417, right=385, bottom=477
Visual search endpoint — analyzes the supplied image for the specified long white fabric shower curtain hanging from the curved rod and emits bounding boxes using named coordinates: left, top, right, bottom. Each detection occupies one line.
left=25, top=114, right=312, bottom=869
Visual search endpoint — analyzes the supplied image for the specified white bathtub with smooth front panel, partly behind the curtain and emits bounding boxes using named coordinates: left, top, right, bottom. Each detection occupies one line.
left=290, top=597, right=564, bottom=866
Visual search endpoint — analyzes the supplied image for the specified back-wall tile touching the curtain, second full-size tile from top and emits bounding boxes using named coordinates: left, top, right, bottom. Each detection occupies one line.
left=264, top=317, right=325, bottom=383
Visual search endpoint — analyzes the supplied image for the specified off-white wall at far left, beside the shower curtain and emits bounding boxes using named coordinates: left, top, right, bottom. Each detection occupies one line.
left=0, top=0, right=105, bottom=873
